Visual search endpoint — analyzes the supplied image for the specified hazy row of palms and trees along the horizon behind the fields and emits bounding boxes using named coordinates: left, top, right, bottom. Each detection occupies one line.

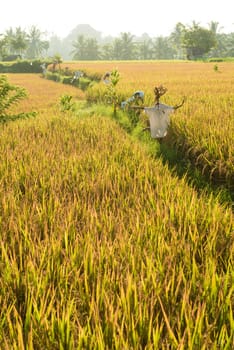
left=0, top=22, right=234, bottom=60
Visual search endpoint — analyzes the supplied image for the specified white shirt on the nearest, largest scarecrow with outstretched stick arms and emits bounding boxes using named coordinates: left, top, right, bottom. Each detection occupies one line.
left=144, top=103, right=175, bottom=139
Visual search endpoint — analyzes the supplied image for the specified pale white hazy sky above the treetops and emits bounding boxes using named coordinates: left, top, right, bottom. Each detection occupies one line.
left=0, top=0, right=234, bottom=38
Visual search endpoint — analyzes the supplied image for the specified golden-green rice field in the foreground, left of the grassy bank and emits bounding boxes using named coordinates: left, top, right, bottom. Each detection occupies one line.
left=0, top=64, right=234, bottom=350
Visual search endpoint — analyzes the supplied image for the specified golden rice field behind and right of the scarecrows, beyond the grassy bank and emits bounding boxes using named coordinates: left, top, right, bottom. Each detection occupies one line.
left=60, top=61, right=234, bottom=186
